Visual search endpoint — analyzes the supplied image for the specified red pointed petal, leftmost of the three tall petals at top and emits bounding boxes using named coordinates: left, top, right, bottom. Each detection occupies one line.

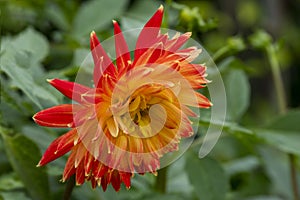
left=90, top=31, right=115, bottom=87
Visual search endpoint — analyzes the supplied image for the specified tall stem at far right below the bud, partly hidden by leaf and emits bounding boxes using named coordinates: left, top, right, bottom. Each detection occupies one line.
left=266, top=44, right=300, bottom=200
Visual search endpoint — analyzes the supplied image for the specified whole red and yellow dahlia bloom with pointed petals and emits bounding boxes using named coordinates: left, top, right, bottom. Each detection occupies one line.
left=33, top=6, right=211, bottom=191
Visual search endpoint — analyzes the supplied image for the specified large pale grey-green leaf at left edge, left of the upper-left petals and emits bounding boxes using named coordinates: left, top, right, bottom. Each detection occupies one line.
left=0, top=28, right=58, bottom=108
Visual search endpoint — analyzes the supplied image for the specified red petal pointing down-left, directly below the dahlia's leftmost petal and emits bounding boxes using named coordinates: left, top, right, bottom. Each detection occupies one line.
left=37, top=129, right=77, bottom=166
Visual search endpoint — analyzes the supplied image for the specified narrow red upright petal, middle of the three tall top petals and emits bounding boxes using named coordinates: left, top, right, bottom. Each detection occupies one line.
left=113, top=21, right=130, bottom=72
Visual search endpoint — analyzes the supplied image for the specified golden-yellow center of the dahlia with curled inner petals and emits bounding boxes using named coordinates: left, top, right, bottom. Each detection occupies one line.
left=104, top=84, right=181, bottom=153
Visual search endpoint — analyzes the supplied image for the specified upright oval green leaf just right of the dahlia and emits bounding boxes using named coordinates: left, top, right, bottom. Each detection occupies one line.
left=225, top=69, right=250, bottom=120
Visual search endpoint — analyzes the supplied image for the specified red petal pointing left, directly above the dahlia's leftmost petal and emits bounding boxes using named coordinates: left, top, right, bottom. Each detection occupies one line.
left=48, top=79, right=90, bottom=103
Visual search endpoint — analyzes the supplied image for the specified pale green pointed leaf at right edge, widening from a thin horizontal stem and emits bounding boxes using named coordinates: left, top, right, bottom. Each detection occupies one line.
left=255, top=129, right=300, bottom=156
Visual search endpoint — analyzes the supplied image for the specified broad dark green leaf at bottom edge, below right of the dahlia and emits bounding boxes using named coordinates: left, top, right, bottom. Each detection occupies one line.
left=186, top=153, right=229, bottom=200
